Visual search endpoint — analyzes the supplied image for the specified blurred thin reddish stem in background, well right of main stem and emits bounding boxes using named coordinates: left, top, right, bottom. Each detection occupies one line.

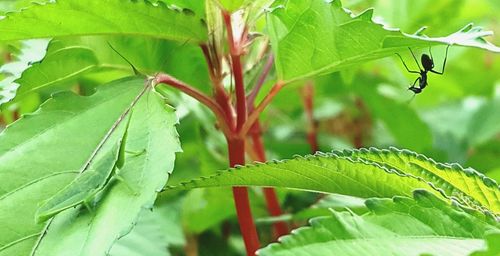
left=302, top=82, right=319, bottom=153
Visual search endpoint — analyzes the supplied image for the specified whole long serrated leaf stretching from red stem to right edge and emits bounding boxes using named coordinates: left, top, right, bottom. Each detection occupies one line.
left=168, top=149, right=500, bottom=215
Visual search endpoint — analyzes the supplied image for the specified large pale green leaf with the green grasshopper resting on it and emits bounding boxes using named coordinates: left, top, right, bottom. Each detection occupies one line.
left=0, top=78, right=179, bottom=255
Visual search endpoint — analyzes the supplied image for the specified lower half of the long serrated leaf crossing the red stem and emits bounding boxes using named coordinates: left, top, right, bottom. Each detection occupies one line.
left=167, top=150, right=438, bottom=202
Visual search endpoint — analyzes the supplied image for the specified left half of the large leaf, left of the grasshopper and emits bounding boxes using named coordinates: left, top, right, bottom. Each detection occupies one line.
left=0, top=78, right=144, bottom=255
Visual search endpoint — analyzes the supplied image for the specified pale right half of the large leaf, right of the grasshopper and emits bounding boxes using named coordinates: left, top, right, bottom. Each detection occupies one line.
left=33, top=83, right=180, bottom=255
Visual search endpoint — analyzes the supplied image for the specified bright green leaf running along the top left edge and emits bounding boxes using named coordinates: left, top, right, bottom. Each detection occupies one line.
left=0, top=0, right=207, bottom=43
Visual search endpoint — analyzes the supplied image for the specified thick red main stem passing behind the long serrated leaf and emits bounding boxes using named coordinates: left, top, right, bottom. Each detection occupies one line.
left=227, top=138, right=260, bottom=256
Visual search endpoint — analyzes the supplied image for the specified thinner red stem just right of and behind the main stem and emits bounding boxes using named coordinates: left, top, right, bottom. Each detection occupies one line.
left=250, top=120, right=288, bottom=240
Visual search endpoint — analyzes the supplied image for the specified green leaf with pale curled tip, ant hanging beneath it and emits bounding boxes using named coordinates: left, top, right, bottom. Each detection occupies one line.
left=268, top=0, right=500, bottom=82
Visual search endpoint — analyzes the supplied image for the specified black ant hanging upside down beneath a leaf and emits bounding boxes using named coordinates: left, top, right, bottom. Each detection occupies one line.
left=396, top=45, right=450, bottom=94
